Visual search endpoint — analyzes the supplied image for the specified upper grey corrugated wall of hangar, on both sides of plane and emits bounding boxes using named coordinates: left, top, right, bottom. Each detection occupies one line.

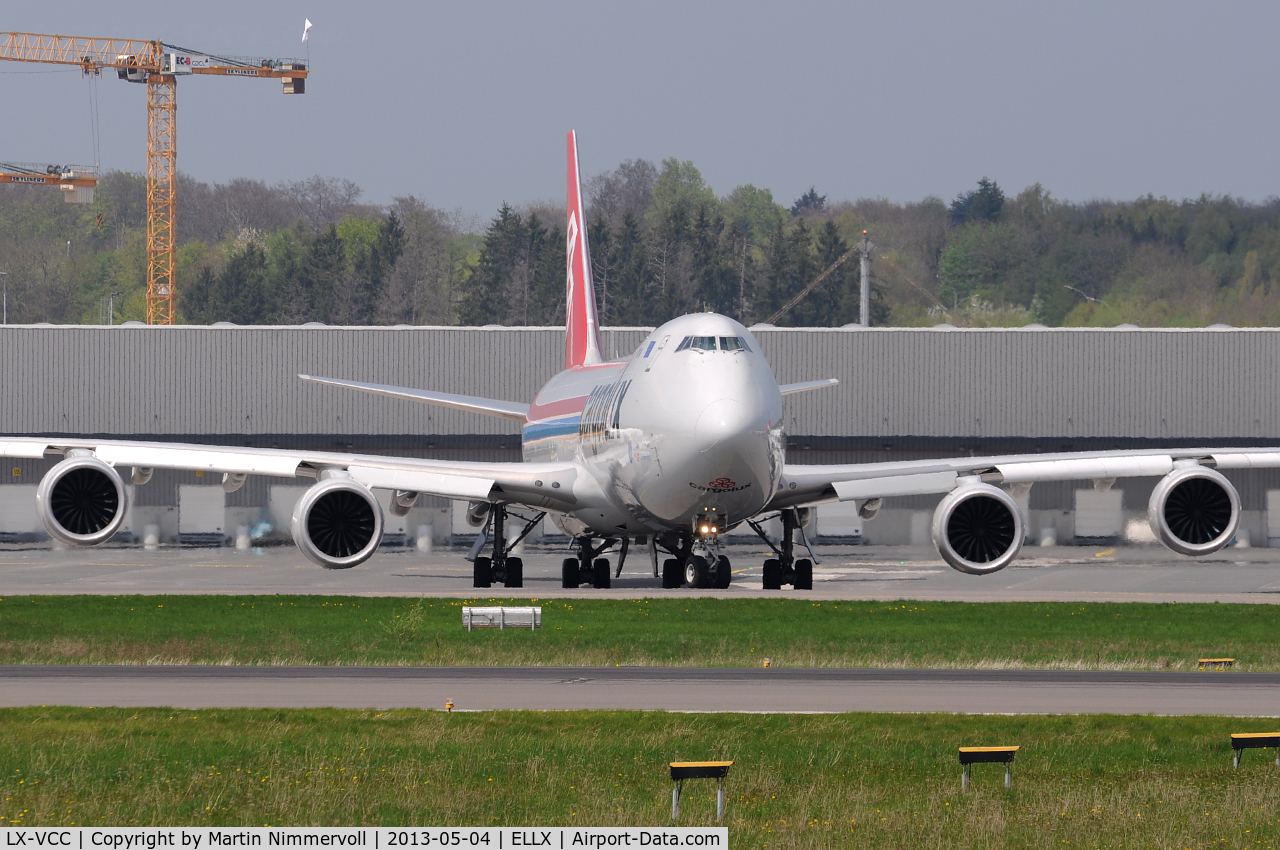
left=0, top=326, right=1280, bottom=443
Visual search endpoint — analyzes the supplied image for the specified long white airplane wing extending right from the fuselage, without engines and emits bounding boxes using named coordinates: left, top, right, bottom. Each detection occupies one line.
left=765, top=448, right=1280, bottom=511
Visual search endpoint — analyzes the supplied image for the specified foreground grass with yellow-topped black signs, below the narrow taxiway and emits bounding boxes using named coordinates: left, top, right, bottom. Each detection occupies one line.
left=0, top=708, right=1280, bottom=847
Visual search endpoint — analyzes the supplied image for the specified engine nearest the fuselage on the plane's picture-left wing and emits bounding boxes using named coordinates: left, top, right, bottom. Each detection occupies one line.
left=289, top=477, right=383, bottom=570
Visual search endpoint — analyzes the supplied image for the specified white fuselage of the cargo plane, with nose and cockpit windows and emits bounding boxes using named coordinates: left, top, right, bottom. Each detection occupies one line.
left=522, top=314, right=785, bottom=536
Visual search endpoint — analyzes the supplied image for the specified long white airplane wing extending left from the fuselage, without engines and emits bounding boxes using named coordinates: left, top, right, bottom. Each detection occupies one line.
left=0, top=437, right=577, bottom=509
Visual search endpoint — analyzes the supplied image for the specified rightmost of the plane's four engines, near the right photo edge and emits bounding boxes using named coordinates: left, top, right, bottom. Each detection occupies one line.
left=1147, top=465, right=1240, bottom=554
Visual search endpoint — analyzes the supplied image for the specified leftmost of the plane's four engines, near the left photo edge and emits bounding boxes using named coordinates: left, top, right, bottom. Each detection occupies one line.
left=36, top=452, right=129, bottom=547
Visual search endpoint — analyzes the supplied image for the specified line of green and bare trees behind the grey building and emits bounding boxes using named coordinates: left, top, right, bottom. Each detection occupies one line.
left=0, top=159, right=1280, bottom=326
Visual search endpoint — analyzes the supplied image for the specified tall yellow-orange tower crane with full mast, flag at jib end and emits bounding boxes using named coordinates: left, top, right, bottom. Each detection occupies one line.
left=0, top=32, right=307, bottom=325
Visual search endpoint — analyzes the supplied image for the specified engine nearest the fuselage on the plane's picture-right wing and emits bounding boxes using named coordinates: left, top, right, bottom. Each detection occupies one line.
left=933, top=484, right=1024, bottom=576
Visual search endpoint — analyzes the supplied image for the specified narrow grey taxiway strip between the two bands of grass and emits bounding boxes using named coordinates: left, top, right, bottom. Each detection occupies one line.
left=0, top=666, right=1280, bottom=717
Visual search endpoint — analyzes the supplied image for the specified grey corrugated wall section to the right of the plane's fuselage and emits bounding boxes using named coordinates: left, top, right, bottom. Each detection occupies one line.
left=758, top=328, right=1280, bottom=440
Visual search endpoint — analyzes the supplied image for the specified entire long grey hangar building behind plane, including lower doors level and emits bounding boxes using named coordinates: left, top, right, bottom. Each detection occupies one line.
left=0, top=324, right=1280, bottom=547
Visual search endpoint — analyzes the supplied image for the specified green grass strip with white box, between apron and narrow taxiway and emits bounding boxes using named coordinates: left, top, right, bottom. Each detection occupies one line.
left=0, top=595, right=1280, bottom=671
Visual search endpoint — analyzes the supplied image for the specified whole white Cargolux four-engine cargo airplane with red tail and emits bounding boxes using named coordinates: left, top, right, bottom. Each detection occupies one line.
left=0, top=132, right=1280, bottom=590
